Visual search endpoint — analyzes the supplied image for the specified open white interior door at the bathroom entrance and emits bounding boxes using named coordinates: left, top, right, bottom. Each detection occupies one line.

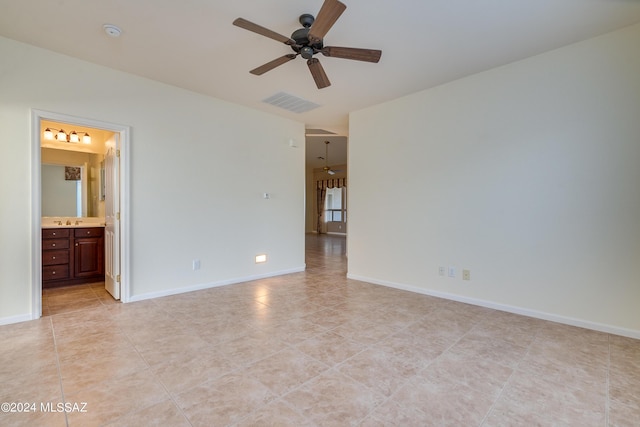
left=104, top=132, right=120, bottom=299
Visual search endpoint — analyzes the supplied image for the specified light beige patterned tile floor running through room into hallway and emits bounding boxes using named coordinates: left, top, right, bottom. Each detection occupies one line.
left=0, top=235, right=640, bottom=427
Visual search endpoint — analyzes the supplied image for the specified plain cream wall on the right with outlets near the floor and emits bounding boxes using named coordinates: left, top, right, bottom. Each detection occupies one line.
left=348, top=25, right=640, bottom=337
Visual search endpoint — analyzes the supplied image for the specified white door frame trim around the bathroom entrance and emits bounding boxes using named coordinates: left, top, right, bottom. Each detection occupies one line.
left=31, top=109, right=131, bottom=319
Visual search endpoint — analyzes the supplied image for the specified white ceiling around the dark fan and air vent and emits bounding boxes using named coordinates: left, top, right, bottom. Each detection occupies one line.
left=0, top=0, right=640, bottom=167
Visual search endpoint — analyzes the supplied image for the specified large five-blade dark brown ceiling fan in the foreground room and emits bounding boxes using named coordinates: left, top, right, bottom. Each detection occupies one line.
left=233, top=0, right=382, bottom=89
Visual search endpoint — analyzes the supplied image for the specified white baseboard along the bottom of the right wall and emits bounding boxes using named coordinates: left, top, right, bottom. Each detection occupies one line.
left=347, top=273, right=640, bottom=339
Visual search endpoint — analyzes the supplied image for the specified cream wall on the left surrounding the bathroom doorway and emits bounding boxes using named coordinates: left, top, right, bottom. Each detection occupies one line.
left=0, top=38, right=304, bottom=324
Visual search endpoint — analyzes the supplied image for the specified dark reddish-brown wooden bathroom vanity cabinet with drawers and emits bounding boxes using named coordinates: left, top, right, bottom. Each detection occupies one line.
left=42, top=227, right=104, bottom=288
